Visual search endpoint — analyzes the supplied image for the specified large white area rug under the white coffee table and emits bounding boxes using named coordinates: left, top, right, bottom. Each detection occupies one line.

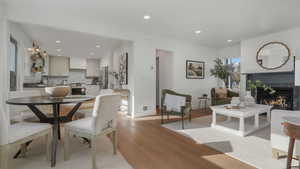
left=163, top=116, right=298, bottom=169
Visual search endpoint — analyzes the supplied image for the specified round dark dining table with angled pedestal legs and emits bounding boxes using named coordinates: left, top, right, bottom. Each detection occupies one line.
left=6, top=96, right=95, bottom=167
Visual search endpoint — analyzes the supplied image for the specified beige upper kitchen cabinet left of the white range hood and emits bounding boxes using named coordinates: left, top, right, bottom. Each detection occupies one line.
left=49, top=56, right=69, bottom=76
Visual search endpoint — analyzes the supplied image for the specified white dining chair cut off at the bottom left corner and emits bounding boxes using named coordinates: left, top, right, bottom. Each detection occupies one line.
left=0, top=122, right=52, bottom=169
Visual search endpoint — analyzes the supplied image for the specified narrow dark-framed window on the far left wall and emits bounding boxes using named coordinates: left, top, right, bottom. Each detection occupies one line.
left=8, top=37, right=18, bottom=91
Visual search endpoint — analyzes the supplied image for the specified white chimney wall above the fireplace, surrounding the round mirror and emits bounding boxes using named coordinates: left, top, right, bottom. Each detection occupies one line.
left=241, top=28, right=300, bottom=73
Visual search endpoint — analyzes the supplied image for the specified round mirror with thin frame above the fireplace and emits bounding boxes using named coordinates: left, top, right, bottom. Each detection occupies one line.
left=256, top=42, right=291, bottom=70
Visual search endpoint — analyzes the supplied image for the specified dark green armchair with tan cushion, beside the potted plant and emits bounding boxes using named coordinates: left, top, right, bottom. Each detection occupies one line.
left=210, top=88, right=239, bottom=106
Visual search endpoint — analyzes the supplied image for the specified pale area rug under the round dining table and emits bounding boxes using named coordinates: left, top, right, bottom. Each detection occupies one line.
left=10, top=136, right=132, bottom=169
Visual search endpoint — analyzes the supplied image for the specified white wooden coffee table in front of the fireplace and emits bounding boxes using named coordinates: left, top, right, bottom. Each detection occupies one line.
left=210, top=104, right=272, bottom=137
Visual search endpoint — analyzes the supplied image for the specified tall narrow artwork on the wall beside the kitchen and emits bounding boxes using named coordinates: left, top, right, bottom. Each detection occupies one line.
left=119, top=53, right=128, bottom=85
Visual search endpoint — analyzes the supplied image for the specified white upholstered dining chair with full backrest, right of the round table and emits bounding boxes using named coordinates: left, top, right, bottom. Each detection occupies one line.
left=64, top=94, right=121, bottom=169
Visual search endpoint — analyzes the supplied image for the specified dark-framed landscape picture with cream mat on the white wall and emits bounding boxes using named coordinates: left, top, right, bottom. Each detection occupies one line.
left=186, top=60, right=205, bottom=79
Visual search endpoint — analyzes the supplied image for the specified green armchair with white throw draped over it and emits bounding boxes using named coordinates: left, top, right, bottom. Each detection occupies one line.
left=161, top=89, right=192, bottom=129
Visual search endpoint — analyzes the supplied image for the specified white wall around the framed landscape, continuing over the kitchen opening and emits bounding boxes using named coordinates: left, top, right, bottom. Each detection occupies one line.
left=3, top=6, right=217, bottom=116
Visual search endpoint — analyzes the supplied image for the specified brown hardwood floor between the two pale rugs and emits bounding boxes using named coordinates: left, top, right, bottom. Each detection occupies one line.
left=118, top=111, right=254, bottom=169
